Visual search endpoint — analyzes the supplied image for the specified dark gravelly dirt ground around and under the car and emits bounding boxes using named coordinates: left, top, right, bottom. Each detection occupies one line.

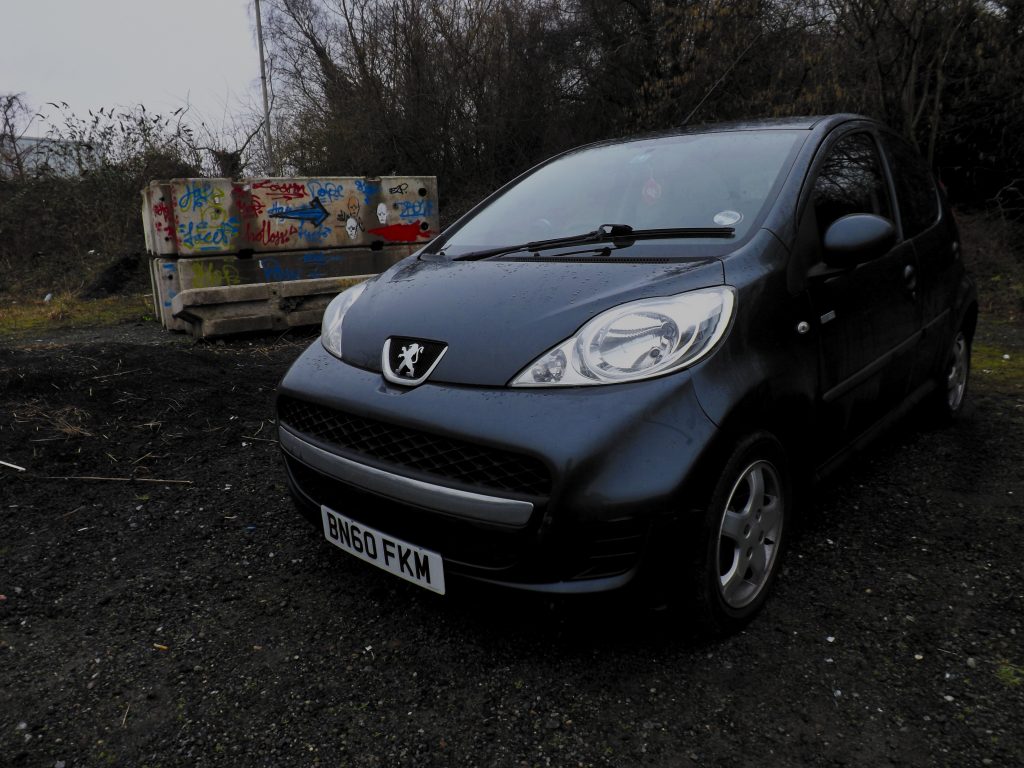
left=0, top=303, right=1024, bottom=768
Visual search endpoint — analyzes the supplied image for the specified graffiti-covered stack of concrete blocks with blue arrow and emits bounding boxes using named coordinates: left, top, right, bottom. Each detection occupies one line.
left=142, top=176, right=438, bottom=337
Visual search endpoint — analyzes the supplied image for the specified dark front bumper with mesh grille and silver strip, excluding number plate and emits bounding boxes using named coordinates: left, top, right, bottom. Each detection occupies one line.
left=278, top=342, right=715, bottom=592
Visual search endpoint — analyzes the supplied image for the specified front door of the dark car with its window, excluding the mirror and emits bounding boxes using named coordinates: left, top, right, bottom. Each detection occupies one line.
left=801, top=128, right=921, bottom=458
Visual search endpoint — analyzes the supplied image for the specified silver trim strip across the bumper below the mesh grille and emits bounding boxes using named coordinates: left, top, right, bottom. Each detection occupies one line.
left=278, top=425, right=534, bottom=527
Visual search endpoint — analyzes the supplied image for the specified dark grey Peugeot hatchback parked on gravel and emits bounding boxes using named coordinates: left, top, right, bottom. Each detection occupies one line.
left=276, top=115, right=978, bottom=630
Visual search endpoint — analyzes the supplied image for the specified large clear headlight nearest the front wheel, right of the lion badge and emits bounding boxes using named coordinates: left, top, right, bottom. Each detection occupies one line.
left=512, top=286, right=735, bottom=387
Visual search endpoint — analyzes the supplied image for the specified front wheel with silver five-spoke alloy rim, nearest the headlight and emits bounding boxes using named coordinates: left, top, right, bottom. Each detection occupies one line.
left=690, top=433, right=793, bottom=635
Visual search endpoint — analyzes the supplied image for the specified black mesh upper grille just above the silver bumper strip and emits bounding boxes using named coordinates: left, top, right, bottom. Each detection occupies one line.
left=278, top=397, right=551, bottom=497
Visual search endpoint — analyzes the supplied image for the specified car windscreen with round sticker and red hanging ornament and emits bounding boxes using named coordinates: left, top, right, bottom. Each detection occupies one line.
left=440, top=130, right=807, bottom=256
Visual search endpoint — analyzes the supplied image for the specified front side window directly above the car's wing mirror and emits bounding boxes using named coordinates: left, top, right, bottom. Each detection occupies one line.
left=813, top=133, right=893, bottom=236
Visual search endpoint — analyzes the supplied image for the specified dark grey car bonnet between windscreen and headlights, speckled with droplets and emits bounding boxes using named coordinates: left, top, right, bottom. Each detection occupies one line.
left=343, top=257, right=724, bottom=386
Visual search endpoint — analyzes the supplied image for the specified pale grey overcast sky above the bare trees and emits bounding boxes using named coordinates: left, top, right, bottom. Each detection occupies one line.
left=0, top=0, right=265, bottom=135
